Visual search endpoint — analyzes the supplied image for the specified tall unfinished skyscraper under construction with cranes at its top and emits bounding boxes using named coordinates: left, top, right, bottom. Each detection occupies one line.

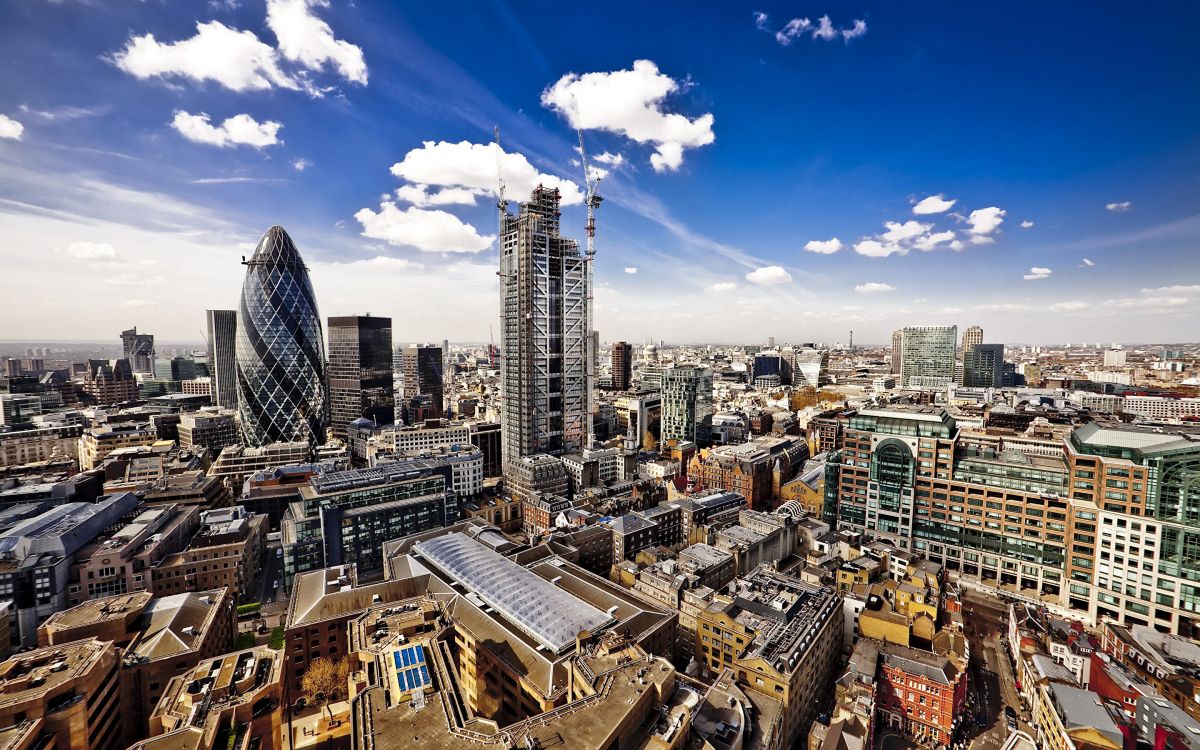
left=499, top=186, right=592, bottom=473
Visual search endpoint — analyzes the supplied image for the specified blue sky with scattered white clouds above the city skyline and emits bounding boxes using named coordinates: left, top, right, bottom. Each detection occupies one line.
left=0, top=0, right=1200, bottom=344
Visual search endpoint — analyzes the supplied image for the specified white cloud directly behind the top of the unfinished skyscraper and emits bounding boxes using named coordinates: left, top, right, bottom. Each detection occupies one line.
left=391, top=140, right=583, bottom=205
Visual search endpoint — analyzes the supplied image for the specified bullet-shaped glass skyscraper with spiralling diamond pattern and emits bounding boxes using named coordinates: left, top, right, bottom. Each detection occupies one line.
left=238, top=227, right=329, bottom=446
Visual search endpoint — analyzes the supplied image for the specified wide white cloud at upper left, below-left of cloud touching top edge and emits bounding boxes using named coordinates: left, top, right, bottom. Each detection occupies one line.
left=113, top=20, right=300, bottom=91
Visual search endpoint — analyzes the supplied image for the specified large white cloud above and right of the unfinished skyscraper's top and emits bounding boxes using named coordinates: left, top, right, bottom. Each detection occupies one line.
left=541, top=60, right=716, bottom=172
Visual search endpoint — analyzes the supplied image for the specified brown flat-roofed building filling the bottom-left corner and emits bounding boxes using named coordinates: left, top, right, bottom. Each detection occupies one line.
left=0, top=638, right=124, bottom=750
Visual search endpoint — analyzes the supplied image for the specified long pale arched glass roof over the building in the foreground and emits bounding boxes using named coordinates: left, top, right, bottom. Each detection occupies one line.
left=415, top=532, right=613, bottom=653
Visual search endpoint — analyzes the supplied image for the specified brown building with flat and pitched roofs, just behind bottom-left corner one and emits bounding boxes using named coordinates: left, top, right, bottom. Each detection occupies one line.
left=37, top=588, right=235, bottom=746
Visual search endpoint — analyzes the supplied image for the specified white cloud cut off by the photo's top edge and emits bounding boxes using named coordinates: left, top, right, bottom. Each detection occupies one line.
left=266, top=0, right=367, bottom=85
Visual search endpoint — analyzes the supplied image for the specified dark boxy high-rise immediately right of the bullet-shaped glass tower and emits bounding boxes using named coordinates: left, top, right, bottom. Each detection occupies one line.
left=328, top=316, right=396, bottom=439
